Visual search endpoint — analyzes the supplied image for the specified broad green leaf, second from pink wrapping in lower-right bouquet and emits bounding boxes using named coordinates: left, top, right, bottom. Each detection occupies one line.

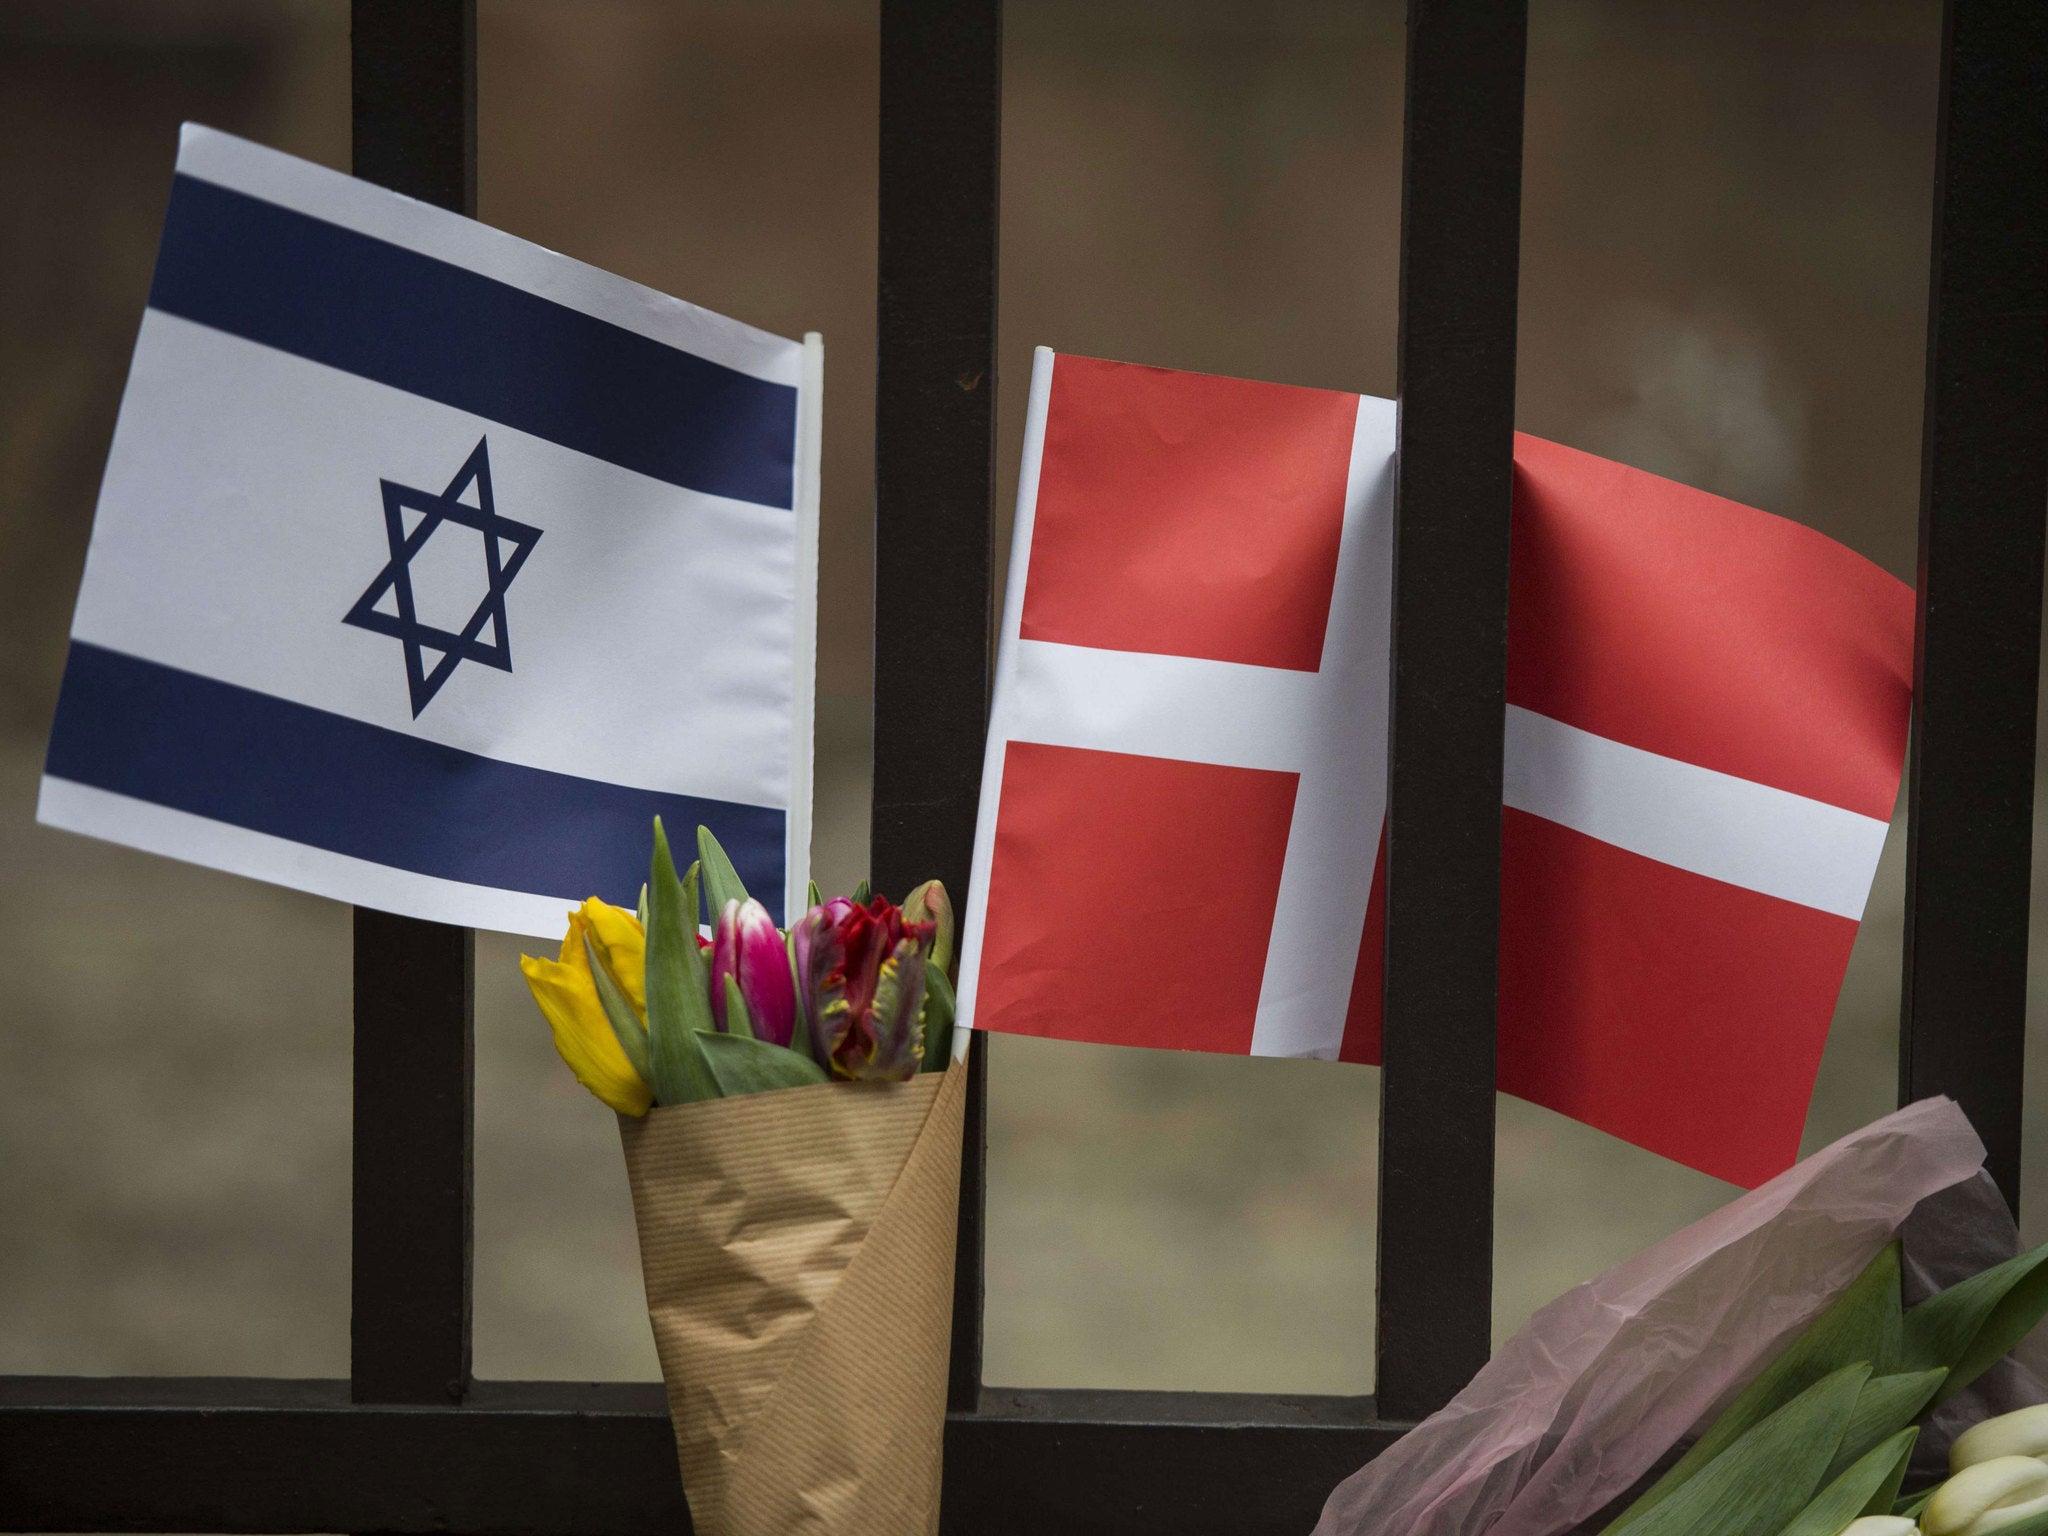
left=1610, top=1364, right=1870, bottom=1536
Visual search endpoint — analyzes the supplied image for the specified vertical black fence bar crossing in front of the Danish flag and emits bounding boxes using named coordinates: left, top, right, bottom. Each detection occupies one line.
left=1376, top=0, right=1528, bottom=1419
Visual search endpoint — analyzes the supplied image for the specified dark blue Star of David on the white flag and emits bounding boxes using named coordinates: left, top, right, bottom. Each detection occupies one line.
left=342, top=438, right=541, bottom=719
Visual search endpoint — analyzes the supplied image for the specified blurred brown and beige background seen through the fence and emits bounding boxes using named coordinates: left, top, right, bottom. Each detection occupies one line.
left=0, top=0, right=2048, bottom=1391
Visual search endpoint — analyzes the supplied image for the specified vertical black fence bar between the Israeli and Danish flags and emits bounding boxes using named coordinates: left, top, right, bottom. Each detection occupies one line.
left=870, top=0, right=1004, bottom=1411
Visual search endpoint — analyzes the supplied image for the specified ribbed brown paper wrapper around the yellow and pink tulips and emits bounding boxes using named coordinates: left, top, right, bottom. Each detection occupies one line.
left=618, top=1061, right=967, bottom=1536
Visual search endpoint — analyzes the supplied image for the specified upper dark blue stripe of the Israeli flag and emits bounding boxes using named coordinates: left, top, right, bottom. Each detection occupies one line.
left=150, top=176, right=797, bottom=508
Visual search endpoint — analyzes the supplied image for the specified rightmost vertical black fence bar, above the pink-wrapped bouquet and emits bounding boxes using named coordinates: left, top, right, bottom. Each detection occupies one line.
left=1898, top=0, right=2048, bottom=1210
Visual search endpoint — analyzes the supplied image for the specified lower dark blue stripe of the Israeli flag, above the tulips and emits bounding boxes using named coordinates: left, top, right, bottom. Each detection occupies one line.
left=45, top=641, right=782, bottom=924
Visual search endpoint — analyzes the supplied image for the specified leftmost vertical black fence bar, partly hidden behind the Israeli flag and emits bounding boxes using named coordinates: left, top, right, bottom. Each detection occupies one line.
left=350, top=0, right=477, bottom=1403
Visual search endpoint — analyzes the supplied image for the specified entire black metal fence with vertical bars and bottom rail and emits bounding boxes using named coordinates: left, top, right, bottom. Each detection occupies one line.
left=0, top=0, right=2048, bottom=1536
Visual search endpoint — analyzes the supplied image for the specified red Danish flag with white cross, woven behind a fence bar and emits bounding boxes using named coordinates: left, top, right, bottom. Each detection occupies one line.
left=961, top=348, right=1913, bottom=1184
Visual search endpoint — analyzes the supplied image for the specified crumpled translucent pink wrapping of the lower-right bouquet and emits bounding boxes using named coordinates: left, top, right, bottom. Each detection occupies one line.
left=1315, top=1098, right=2009, bottom=1536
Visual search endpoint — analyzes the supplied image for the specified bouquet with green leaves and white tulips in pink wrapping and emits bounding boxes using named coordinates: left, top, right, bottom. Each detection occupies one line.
left=1317, top=1100, right=2048, bottom=1536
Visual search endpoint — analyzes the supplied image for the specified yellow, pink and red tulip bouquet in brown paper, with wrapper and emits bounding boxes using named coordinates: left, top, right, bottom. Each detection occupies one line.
left=520, top=821, right=967, bottom=1536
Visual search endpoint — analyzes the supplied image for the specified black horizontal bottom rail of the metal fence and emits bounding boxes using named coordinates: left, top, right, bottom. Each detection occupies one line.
left=0, top=1376, right=1407, bottom=1536
